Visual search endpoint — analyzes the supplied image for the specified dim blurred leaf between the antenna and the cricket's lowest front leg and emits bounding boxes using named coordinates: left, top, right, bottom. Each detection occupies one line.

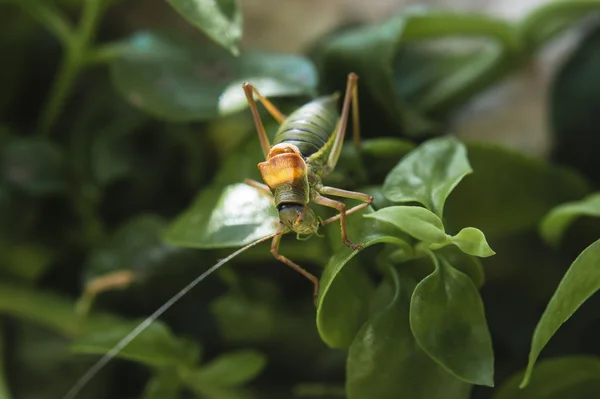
left=210, top=293, right=277, bottom=342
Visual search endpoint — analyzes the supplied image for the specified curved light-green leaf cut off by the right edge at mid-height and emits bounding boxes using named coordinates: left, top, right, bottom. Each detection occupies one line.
left=540, top=193, right=600, bottom=246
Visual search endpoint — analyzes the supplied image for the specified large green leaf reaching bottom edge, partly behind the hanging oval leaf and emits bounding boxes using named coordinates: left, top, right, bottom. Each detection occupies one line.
left=346, top=268, right=470, bottom=399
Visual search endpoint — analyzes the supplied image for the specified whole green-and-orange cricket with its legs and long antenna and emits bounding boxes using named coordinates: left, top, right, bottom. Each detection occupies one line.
left=63, top=73, right=373, bottom=399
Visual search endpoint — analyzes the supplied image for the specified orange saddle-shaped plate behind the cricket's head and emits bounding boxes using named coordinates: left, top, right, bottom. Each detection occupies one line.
left=258, top=144, right=306, bottom=189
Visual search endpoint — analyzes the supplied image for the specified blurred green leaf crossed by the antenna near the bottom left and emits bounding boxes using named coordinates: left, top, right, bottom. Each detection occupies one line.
left=71, top=321, right=200, bottom=367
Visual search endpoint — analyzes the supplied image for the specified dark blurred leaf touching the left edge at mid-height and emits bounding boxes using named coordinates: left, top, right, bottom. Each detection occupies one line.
left=0, top=138, right=67, bottom=196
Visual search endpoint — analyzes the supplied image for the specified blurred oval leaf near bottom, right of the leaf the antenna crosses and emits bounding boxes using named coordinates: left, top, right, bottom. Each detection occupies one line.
left=185, top=350, right=267, bottom=387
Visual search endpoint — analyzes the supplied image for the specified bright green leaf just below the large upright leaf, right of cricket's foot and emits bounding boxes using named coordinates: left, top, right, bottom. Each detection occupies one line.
left=365, top=206, right=448, bottom=244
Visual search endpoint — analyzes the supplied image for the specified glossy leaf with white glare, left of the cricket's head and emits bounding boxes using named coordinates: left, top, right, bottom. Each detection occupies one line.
left=165, top=183, right=279, bottom=248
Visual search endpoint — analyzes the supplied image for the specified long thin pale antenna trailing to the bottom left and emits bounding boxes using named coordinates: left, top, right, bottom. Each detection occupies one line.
left=63, top=232, right=281, bottom=399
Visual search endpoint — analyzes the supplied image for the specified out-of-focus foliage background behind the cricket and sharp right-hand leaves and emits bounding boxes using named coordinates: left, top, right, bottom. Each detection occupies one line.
left=0, top=0, right=600, bottom=399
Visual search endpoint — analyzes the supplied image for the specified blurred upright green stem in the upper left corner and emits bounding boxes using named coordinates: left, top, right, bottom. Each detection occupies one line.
left=38, top=0, right=103, bottom=136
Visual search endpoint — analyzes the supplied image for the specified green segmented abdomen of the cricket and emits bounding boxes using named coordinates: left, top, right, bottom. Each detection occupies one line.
left=274, top=96, right=338, bottom=157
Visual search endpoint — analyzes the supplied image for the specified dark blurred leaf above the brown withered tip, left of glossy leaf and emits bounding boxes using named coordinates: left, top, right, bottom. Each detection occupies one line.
left=85, top=214, right=200, bottom=281
